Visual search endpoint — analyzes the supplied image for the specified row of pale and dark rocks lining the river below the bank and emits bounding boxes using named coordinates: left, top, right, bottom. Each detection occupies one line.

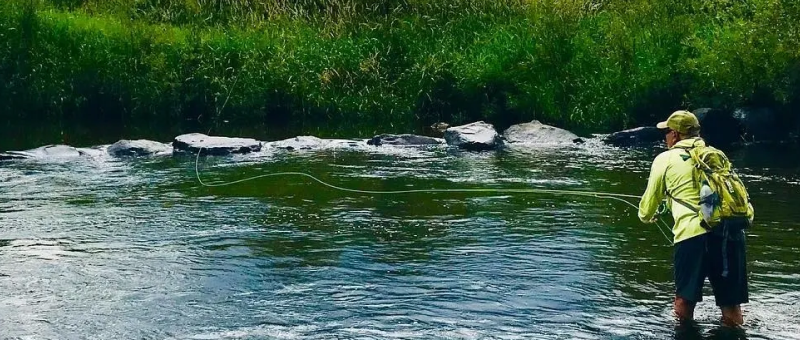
left=0, top=109, right=787, bottom=160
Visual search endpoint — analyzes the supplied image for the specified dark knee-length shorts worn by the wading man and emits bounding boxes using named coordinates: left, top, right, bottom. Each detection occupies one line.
left=674, top=222, right=749, bottom=307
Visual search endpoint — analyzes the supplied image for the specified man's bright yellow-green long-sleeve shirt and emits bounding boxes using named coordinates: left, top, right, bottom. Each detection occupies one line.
left=639, top=138, right=706, bottom=243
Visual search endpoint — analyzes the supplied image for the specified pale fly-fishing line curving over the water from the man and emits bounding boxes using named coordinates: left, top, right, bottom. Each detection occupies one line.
left=194, top=147, right=673, bottom=245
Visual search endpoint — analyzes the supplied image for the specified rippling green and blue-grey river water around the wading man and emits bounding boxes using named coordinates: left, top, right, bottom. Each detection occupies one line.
left=0, top=129, right=800, bottom=339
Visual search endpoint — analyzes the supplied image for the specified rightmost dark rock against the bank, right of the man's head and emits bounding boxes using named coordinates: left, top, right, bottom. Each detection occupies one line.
left=733, top=108, right=789, bottom=142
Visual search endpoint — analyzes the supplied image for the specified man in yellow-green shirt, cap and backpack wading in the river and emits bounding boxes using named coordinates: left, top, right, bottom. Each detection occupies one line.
left=639, top=111, right=753, bottom=326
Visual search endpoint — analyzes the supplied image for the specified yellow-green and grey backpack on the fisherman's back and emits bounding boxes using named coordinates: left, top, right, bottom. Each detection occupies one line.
left=672, top=139, right=750, bottom=230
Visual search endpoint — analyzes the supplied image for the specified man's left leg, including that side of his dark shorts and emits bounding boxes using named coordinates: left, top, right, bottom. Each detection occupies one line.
left=673, top=235, right=706, bottom=321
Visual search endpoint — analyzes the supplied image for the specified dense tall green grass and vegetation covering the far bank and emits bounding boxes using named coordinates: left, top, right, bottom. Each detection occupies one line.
left=0, top=0, right=800, bottom=135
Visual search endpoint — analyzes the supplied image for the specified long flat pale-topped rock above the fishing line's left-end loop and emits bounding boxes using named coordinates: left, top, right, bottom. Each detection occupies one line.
left=172, top=133, right=261, bottom=155
